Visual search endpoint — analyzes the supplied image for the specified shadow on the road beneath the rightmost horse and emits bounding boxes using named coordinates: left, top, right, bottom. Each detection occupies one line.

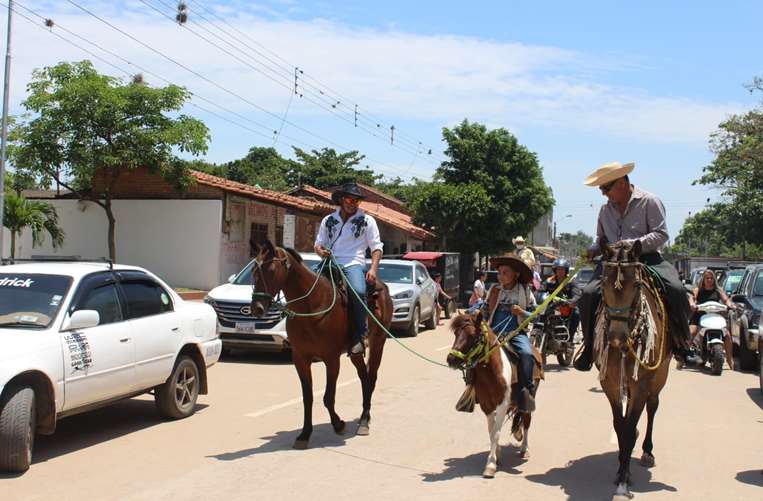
left=526, top=451, right=678, bottom=501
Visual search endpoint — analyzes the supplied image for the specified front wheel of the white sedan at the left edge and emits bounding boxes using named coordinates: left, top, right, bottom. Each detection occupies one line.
left=0, top=386, right=37, bottom=473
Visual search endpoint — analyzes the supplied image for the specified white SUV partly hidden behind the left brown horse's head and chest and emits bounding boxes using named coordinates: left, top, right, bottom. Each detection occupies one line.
left=204, top=252, right=321, bottom=352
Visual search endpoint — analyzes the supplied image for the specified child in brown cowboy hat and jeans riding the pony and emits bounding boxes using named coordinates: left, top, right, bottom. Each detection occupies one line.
left=487, top=254, right=536, bottom=412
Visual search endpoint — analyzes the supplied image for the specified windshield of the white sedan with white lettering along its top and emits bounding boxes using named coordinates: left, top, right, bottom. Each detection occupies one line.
left=0, top=273, right=72, bottom=329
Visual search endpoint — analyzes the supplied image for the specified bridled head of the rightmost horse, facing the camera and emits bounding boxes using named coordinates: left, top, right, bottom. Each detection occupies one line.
left=600, top=240, right=643, bottom=349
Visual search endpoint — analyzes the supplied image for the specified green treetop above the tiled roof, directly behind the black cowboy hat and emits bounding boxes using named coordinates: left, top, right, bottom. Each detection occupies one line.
left=288, top=147, right=382, bottom=189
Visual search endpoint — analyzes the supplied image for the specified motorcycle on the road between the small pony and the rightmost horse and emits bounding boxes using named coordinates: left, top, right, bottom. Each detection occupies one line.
left=530, top=293, right=575, bottom=367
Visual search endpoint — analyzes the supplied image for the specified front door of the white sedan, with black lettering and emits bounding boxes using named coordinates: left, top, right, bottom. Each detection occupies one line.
left=61, top=273, right=135, bottom=411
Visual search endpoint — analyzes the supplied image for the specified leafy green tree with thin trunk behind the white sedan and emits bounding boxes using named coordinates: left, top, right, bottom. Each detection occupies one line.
left=11, top=61, right=209, bottom=259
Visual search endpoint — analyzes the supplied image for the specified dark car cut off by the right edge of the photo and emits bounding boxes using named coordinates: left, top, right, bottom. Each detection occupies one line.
left=731, top=263, right=763, bottom=371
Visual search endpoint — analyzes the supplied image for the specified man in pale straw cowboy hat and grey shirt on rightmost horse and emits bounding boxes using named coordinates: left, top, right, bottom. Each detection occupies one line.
left=575, top=162, right=697, bottom=371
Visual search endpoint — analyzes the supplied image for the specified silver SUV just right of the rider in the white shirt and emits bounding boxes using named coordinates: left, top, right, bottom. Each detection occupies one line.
left=378, top=259, right=437, bottom=336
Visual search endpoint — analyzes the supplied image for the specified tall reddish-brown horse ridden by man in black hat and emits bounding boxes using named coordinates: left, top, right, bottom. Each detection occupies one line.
left=252, top=242, right=392, bottom=449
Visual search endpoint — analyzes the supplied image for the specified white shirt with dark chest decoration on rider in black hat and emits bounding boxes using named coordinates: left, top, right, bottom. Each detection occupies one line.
left=315, top=209, right=384, bottom=266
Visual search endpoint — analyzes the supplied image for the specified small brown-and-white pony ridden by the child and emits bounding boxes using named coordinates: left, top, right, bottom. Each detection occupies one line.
left=447, top=310, right=539, bottom=478
